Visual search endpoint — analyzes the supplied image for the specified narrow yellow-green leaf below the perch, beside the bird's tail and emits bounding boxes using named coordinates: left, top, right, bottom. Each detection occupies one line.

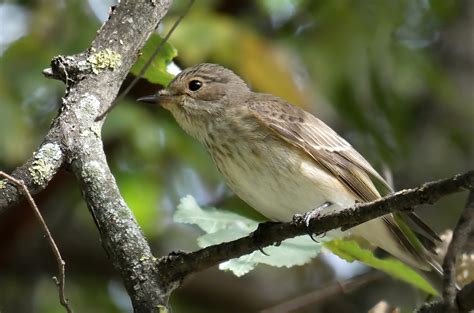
left=324, top=239, right=438, bottom=295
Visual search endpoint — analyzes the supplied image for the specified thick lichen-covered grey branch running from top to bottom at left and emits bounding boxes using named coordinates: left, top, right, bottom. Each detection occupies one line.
left=47, top=0, right=171, bottom=312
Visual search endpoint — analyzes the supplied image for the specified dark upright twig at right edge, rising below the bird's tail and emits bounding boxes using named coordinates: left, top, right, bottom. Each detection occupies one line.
left=443, top=190, right=474, bottom=312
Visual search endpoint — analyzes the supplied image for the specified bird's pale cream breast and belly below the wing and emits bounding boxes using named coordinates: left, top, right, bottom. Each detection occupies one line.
left=207, top=134, right=348, bottom=221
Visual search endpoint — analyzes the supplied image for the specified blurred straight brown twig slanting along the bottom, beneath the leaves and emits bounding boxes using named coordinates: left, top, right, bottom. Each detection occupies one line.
left=260, top=271, right=386, bottom=313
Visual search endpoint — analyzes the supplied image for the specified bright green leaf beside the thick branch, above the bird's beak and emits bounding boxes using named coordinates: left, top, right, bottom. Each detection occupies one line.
left=131, top=34, right=178, bottom=86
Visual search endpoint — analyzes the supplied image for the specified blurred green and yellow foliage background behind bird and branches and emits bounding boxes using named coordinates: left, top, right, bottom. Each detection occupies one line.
left=0, top=0, right=474, bottom=313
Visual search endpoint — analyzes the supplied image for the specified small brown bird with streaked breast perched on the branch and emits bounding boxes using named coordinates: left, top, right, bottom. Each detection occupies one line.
left=139, top=64, right=441, bottom=280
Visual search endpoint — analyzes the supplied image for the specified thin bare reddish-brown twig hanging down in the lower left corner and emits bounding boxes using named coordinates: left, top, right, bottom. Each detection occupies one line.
left=0, top=171, right=72, bottom=313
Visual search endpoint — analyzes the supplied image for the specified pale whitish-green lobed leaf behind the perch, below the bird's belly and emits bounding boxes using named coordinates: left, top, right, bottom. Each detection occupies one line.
left=174, top=196, right=322, bottom=276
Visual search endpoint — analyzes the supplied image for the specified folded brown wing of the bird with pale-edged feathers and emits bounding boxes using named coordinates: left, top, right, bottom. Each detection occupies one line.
left=250, top=95, right=391, bottom=201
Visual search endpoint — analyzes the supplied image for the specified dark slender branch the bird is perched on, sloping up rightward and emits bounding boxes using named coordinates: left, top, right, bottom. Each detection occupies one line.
left=156, top=171, right=474, bottom=282
